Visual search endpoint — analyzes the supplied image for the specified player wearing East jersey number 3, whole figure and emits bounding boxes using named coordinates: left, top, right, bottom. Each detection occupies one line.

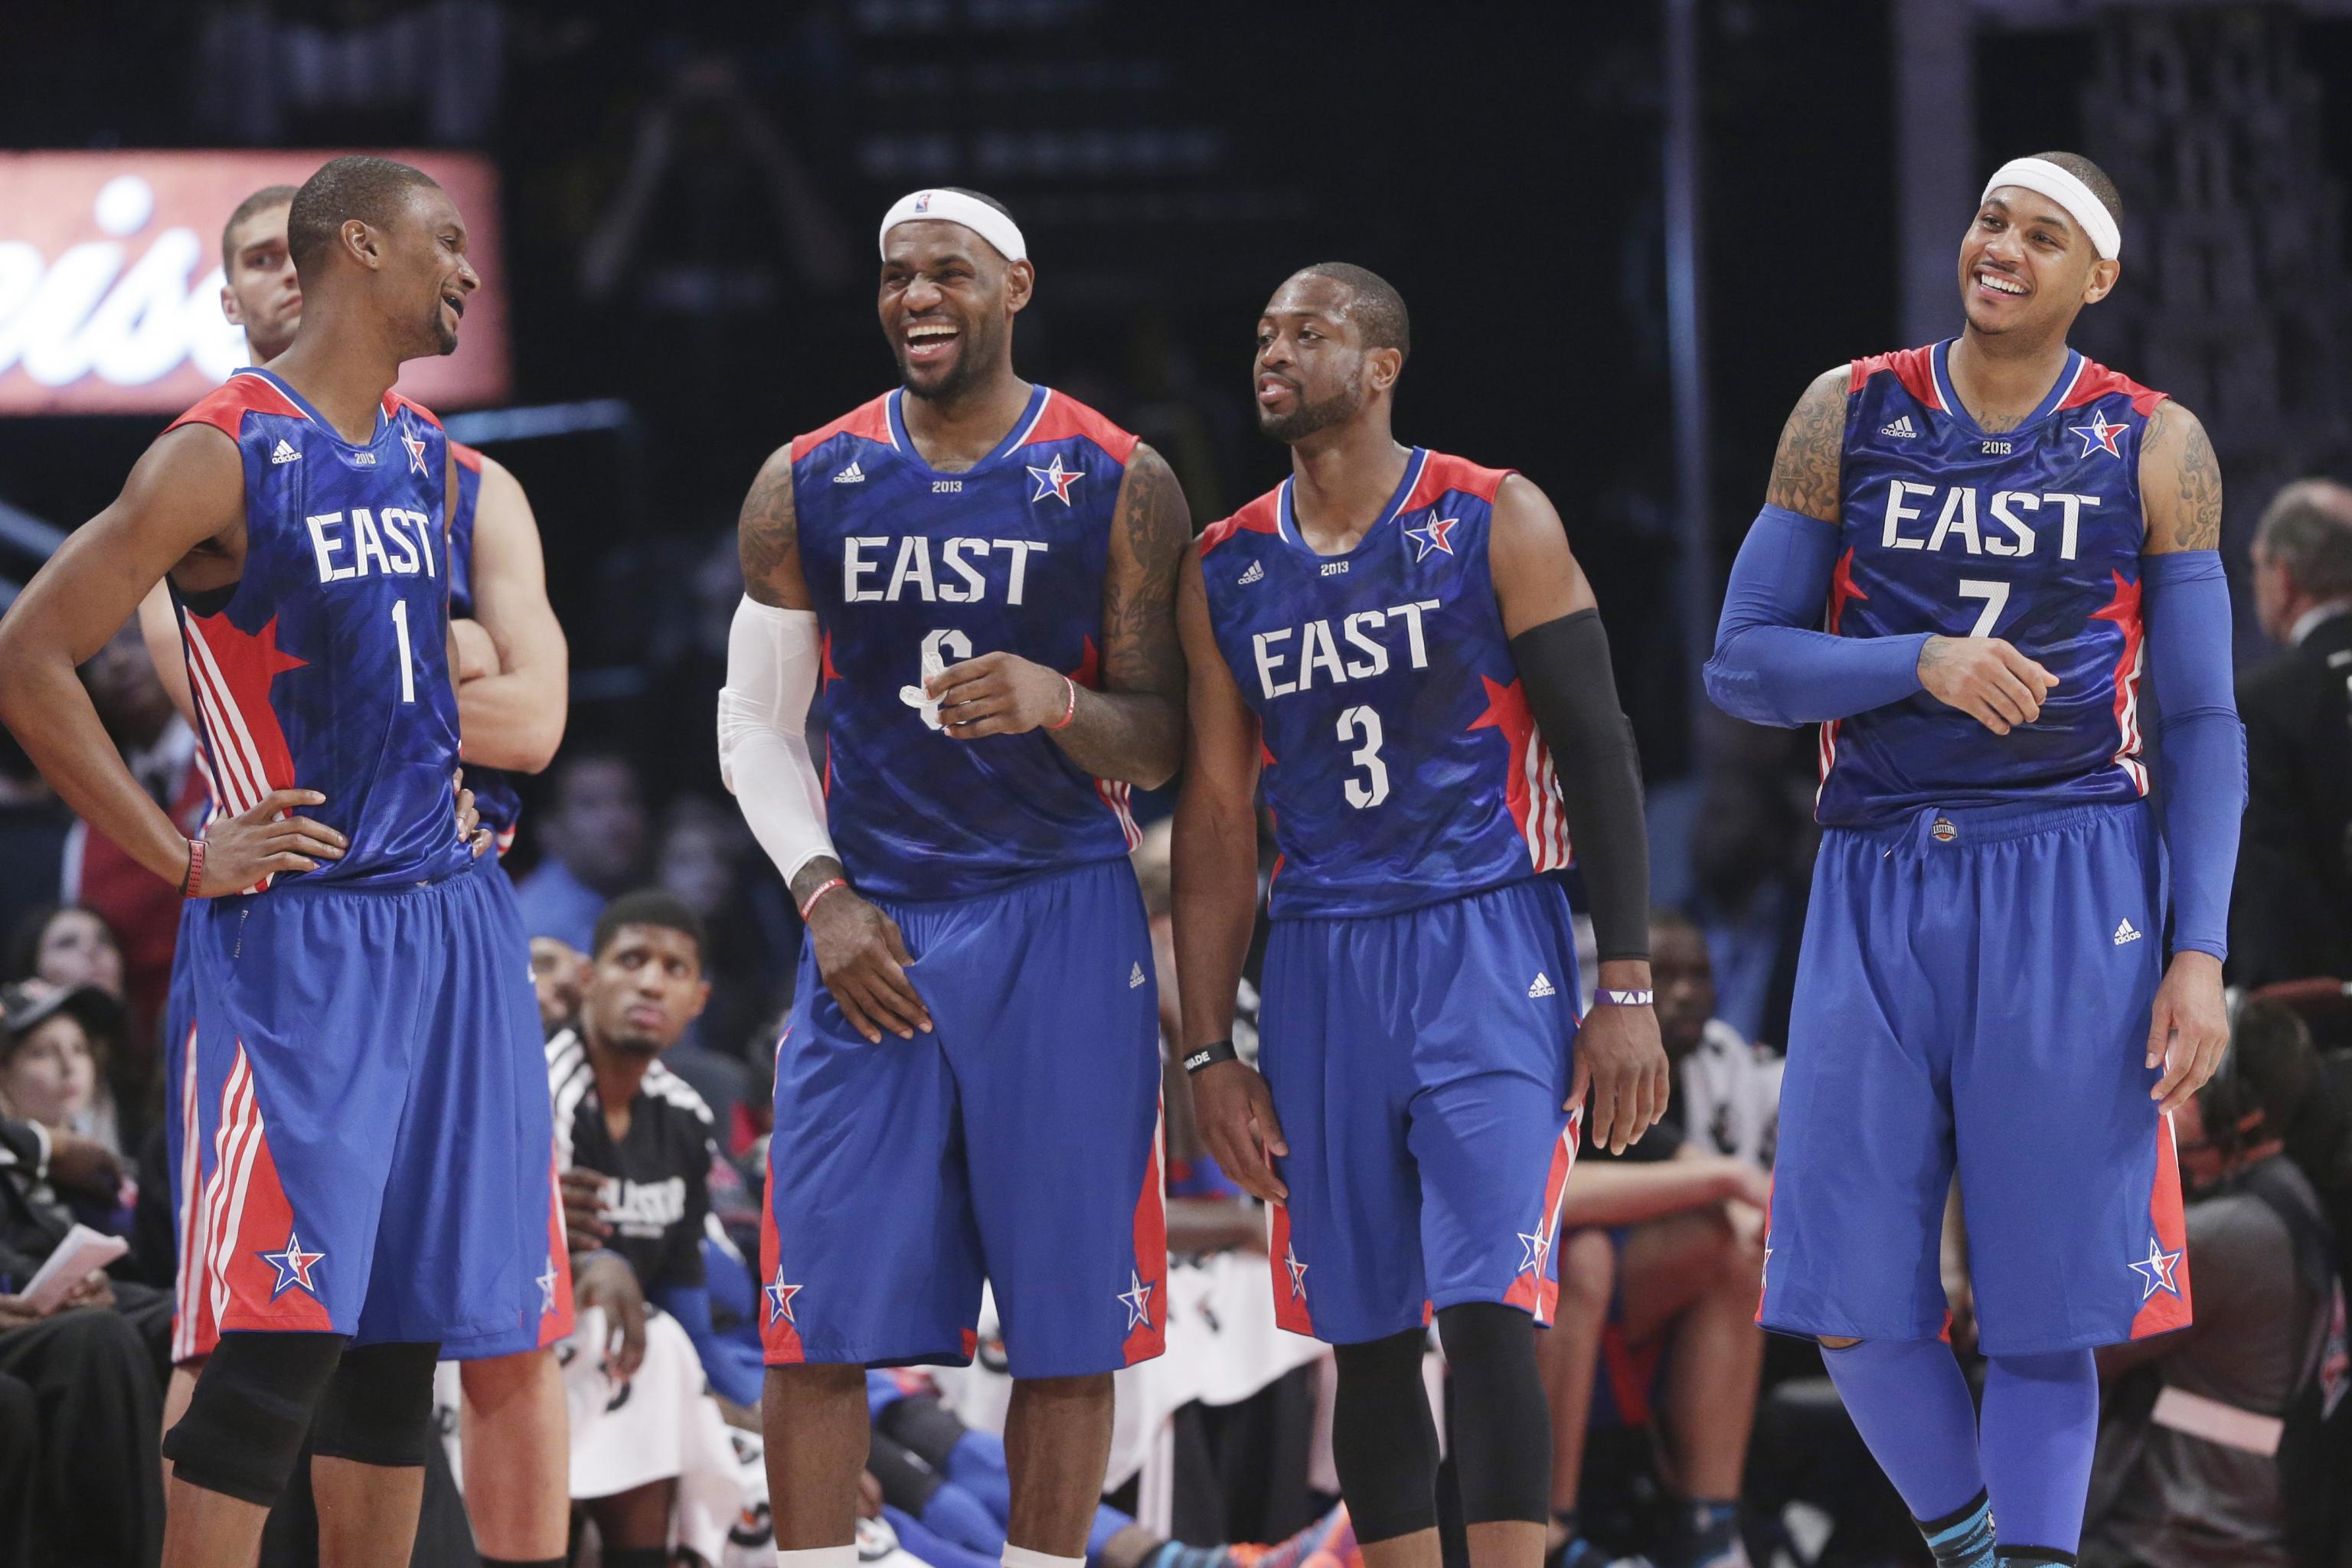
left=1174, top=263, right=1668, bottom=1568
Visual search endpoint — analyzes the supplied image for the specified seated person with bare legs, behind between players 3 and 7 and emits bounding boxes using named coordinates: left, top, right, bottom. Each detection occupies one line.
left=1538, top=910, right=1781, bottom=1568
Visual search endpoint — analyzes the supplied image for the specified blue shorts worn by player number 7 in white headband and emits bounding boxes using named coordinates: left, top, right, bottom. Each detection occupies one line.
left=1757, top=804, right=2190, bottom=1357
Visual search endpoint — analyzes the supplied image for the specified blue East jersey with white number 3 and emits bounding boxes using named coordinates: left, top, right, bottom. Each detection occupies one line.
left=1200, top=446, right=1569, bottom=920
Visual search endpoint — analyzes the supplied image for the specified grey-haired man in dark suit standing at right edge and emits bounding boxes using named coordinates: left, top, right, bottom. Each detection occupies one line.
left=2230, top=479, right=2352, bottom=988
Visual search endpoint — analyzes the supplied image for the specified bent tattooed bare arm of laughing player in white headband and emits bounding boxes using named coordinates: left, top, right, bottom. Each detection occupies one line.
left=929, top=444, right=1193, bottom=790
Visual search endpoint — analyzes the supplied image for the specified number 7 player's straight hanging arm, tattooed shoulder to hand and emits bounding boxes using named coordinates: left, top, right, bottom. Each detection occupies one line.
left=2141, top=400, right=2246, bottom=1112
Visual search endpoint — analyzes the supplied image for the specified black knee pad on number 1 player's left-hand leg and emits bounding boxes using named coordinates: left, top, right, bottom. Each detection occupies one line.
left=162, top=1331, right=348, bottom=1507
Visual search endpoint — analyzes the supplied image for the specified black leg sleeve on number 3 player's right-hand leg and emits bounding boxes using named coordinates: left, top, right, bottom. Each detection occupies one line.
left=1437, top=1302, right=1553, bottom=1524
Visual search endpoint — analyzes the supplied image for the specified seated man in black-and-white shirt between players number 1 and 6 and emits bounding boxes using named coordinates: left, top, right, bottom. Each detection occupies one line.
left=548, top=889, right=762, bottom=1568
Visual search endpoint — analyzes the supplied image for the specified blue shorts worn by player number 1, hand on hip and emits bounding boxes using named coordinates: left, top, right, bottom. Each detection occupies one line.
left=169, top=858, right=571, bottom=1361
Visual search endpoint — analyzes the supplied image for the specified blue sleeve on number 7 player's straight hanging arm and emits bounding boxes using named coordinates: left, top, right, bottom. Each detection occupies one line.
left=2141, top=550, right=2246, bottom=959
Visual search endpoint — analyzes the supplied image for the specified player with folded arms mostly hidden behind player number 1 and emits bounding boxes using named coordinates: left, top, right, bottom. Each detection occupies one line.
left=139, top=186, right=571, bottom=1568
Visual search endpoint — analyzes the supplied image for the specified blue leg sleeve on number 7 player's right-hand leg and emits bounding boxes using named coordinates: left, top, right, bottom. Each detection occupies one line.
left=1983, top=1349, right=2098, bottom=1561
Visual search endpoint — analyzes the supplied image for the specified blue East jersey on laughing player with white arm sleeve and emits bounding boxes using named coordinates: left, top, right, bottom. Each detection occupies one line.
left=792, top=386, right=1136, bottom=898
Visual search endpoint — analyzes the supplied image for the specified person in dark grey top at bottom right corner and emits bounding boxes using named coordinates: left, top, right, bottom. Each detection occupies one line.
left=2082, top=1001, right=2345, bottom=1568
